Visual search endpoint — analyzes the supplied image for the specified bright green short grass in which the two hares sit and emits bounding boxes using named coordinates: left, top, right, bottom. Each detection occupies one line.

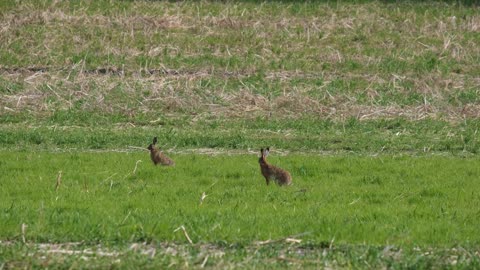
left=0, top=151, right=480, bottom=266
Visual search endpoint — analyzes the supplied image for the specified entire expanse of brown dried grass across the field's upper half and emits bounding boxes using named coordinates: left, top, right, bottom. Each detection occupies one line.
left=0, top=2, right=480, bottom=121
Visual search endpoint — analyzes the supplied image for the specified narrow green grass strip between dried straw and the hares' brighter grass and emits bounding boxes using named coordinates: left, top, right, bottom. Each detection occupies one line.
left=0, top=117, right=480, bottom=156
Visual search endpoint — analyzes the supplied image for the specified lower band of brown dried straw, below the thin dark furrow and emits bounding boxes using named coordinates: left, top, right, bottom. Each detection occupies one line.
left=0, top=66, right=480, bottom=121
